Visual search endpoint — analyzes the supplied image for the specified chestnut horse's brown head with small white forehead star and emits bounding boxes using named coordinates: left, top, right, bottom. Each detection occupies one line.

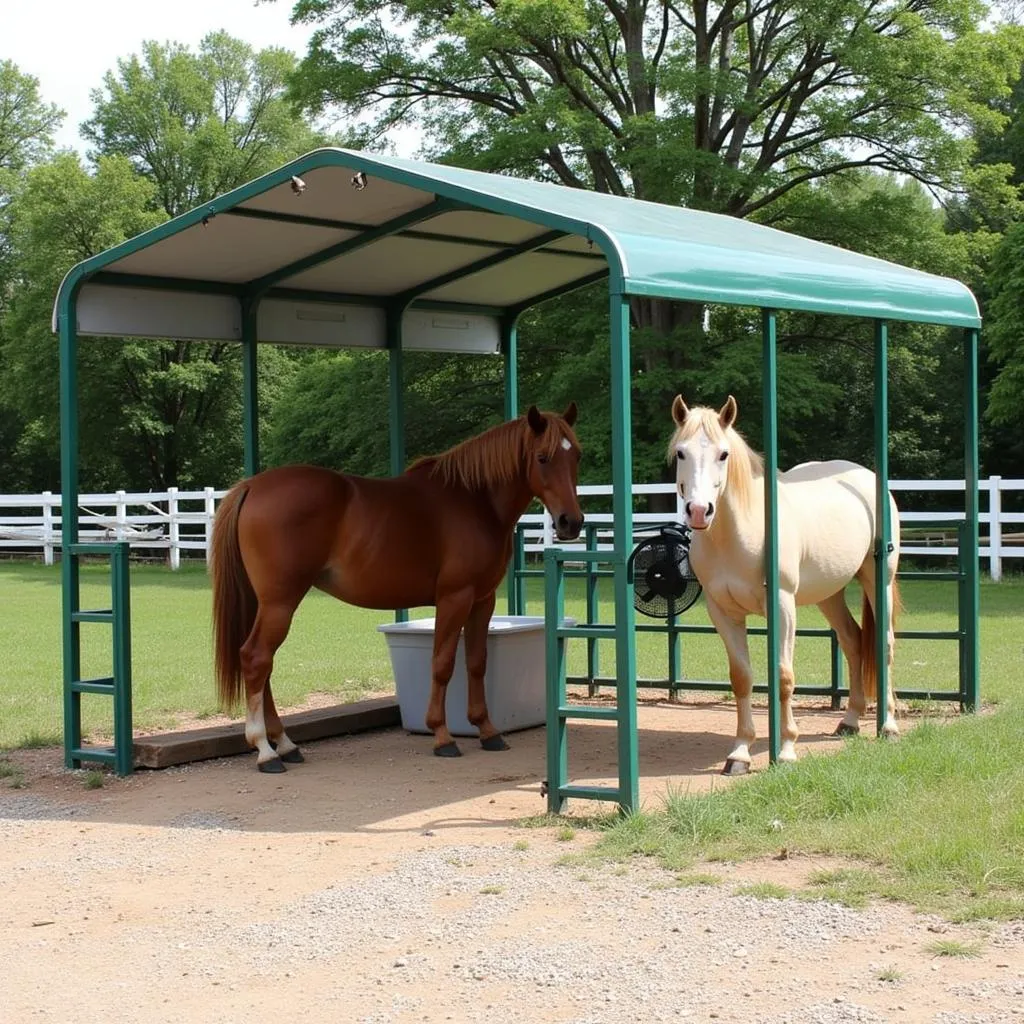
left=526, top=401, right=583, bottom=541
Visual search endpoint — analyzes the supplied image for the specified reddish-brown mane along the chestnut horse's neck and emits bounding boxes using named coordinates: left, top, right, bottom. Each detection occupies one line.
left=410, top=413, right=580, bottom=490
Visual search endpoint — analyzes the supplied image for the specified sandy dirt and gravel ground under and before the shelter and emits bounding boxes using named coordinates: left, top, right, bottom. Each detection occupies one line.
left=0, top=702, right=1024, bottom=1024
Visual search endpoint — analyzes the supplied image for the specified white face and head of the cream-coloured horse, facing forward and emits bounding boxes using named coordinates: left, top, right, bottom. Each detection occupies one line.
left=669, top=394, right=736, bottom=529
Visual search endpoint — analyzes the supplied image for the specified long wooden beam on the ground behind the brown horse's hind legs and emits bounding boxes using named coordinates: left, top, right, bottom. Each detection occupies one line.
left=134, top=697, right=401, bottom=768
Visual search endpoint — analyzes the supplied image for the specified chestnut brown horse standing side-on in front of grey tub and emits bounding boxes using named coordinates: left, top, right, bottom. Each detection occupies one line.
left=210, top=402, right=583, bottom=772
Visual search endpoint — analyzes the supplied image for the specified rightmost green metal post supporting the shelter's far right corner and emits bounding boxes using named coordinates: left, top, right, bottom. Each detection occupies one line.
left=963, top=330, right=981, bottom=712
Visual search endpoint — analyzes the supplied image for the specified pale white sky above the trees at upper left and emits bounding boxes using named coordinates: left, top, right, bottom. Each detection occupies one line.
left=0, top=0, right=412, bottom=155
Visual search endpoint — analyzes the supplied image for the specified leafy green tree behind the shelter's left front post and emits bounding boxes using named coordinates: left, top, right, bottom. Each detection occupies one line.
left=0, top=153, right=296, bottom=489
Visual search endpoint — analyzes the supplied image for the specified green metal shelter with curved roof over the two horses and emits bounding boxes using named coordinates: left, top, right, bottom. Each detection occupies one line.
left=53, top=148, right=980, bottom=809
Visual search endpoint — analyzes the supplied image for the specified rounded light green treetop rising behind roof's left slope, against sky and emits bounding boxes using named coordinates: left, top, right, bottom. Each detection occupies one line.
left=81, top=32, right=329, bottom=217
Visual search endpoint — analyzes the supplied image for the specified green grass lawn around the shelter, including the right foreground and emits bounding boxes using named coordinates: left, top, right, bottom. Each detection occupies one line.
left=0, top=563, right=1024, bottom=921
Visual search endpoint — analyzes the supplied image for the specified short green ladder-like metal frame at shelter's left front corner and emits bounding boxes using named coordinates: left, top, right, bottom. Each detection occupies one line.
left=61, top=541, right=134, bottom=775
